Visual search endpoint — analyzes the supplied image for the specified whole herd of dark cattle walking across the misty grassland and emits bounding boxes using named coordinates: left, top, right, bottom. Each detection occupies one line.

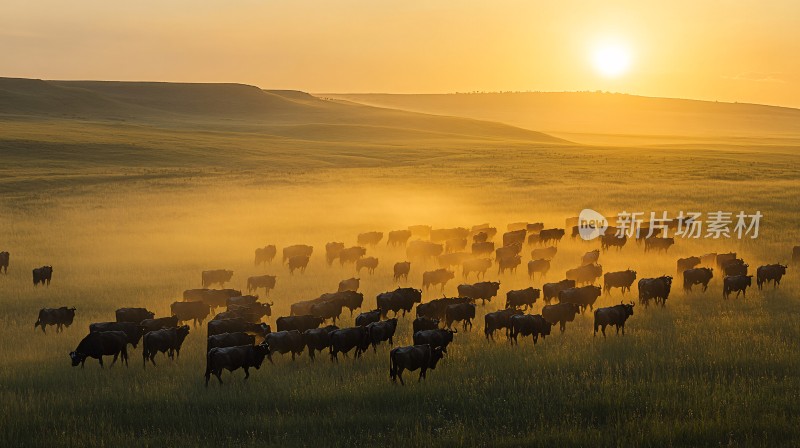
left=10, top=222, right=800, bottom=386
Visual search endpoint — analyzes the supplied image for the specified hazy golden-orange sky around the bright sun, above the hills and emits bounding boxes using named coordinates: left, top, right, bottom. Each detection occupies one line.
left=0, top=0, right=800, bottom=107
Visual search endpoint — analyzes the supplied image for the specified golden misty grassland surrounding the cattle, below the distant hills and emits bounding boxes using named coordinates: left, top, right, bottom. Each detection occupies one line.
left=0, top=79, right=800, bottom=446
